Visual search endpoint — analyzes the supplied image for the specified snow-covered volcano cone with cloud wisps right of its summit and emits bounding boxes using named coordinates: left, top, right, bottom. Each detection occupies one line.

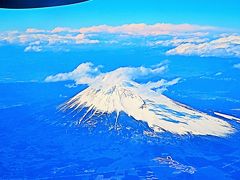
left=57, top=63, right=234, bottom=136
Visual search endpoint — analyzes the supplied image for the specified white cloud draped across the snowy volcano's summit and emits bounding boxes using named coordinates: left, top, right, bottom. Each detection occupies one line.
left=45, top=62, right=167, bottom=85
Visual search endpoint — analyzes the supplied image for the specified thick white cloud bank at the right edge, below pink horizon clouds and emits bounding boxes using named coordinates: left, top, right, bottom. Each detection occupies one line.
left=166, top=35, right=240, bottom=57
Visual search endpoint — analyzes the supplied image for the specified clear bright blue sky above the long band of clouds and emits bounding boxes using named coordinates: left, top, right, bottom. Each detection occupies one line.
left=0, top=0, right=240, bottom=30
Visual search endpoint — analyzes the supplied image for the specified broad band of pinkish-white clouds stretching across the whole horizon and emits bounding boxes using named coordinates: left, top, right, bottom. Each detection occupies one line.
left=0, top=23, right=240, bottom=57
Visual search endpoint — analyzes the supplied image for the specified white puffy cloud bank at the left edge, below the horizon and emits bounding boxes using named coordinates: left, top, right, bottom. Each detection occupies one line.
left=0, top=28, right=99, bottom=52
